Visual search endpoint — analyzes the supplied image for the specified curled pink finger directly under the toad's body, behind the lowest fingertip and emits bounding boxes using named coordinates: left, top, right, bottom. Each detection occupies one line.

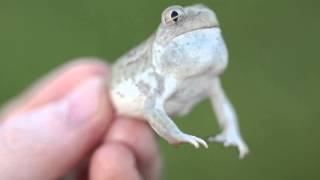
left=101, top=118, right=161, bottom=180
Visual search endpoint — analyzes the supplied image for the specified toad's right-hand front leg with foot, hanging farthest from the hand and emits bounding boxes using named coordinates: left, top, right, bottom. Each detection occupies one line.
left=208, top=78, right=249, bottom=158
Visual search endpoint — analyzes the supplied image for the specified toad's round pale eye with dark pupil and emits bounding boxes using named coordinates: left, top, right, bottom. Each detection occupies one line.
left=162, top=6, right=184, bottom=25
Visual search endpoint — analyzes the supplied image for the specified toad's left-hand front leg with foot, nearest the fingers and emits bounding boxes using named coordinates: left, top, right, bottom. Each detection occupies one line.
left=143, top=97, right=208, bottom=148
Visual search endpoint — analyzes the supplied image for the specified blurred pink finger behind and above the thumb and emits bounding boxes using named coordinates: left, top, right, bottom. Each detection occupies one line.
left=3, top=58, right=108, bottom=119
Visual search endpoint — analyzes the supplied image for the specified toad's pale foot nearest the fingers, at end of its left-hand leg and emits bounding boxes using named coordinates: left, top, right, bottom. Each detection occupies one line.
left=171, top=133, right=208, bottom=148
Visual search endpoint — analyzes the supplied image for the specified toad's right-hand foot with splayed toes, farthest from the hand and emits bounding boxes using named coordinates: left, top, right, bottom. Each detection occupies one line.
left=208, top=131, right=249, bottom=159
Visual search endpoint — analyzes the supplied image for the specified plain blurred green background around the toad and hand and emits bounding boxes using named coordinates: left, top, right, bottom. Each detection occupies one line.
left=0, top=0, right=320, bottom=180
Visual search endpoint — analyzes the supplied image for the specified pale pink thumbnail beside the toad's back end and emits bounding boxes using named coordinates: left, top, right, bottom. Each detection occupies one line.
left=66, top=78, right=105, bottom=122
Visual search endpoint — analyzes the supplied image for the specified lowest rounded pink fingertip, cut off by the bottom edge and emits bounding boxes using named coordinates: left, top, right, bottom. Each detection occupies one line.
left=90, top=142, right=142, bottom=180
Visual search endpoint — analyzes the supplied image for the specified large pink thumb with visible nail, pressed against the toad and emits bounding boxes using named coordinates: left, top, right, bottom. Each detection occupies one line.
left=0, top=78, right=112, bottom=179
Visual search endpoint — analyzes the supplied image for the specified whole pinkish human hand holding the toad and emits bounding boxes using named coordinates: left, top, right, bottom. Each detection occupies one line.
left=0, top=58, right=161, bottom=180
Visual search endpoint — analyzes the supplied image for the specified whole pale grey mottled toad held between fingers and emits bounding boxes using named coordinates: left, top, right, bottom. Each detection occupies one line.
left=109, top=4, right=249, bottom=157
